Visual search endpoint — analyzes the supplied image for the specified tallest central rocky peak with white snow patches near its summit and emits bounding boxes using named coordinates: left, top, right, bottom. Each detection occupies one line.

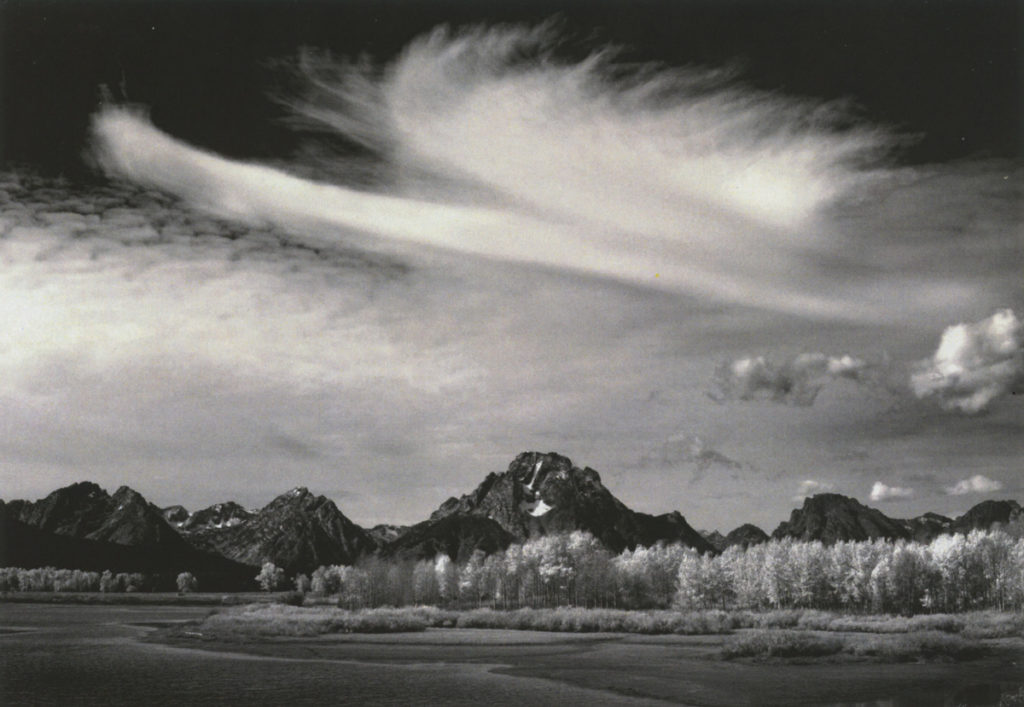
left=423, top=452, right=714, bottom=552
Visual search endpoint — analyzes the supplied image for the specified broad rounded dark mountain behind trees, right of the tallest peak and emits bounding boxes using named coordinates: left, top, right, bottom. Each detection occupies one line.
left=771, top=494, right=910, bottom=543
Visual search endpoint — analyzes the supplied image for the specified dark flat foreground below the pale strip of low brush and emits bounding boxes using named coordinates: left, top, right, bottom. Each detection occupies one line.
left=6, top=604, right=1024, bottom=705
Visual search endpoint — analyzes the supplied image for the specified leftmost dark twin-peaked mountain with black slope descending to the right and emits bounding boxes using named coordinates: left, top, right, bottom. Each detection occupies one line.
left=0, top=484, right=255, bottom=591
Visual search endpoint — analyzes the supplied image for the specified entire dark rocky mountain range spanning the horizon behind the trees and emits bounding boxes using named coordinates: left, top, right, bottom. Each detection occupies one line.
left=0, top=452, right=1024, bottom=589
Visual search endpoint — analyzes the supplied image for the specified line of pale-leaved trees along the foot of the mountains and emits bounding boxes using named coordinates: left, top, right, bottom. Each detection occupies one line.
left=0, top=527, right=1024, bottom=614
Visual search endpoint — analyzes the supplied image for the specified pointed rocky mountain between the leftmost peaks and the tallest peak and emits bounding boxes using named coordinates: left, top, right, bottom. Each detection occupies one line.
left=188, top=488, right=379, bottom=573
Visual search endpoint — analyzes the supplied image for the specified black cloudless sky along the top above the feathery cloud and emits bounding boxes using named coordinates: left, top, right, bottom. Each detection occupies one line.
left=0, top=0, right=1022, bottom=170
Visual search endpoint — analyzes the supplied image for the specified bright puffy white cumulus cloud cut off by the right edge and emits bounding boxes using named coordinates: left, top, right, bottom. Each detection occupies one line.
left=910, top=308, right=1024, bottom=414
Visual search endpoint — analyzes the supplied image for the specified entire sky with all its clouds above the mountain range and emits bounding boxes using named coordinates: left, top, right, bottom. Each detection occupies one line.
left=0, top=0, right=1024, bottom=532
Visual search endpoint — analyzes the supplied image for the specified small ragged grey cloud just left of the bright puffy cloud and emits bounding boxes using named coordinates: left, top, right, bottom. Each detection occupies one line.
left=710, top=354, right=871, bottom=406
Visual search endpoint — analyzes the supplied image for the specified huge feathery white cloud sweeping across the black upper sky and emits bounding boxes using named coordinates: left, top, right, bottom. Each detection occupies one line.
left=94, top=28, right=1015, bottom=321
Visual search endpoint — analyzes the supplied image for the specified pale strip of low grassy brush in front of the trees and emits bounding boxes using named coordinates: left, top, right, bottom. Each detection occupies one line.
left=159, top=602, right=1024, bottom=663
